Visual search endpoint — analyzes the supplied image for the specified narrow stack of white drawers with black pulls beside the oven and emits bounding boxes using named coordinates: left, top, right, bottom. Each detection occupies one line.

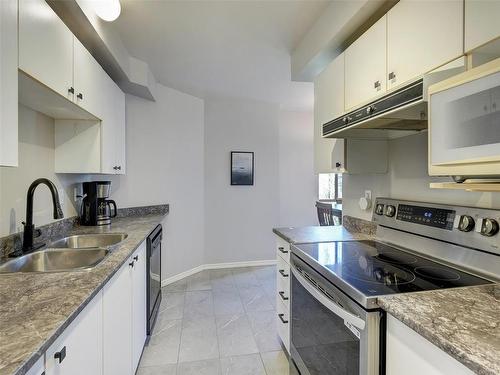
left=276, top=236, right=291, bottom=353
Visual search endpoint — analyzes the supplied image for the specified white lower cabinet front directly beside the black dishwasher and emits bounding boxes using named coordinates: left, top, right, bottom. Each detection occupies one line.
left=103, top=242, right=146, bottom=375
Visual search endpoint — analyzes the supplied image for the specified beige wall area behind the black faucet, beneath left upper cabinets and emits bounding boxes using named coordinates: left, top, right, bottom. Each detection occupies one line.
left=0, top=105, right=85, bottom=237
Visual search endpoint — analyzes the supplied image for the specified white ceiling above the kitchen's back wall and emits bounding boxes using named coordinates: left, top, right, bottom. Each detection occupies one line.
left=112, top=0, right=329, bottom=109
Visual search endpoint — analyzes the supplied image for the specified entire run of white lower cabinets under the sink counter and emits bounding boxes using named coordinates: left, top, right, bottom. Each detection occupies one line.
left=31, top=241, right=147, bottom=375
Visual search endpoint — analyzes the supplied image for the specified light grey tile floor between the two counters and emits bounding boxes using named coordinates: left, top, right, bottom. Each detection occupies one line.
left=137, top=266, right=288, bottom=375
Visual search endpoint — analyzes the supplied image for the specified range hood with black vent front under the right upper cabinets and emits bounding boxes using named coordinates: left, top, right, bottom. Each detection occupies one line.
left=323, top=58, right=465, bottom=139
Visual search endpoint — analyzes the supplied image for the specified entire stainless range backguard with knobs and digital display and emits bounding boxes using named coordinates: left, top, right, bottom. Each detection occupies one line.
left=372, top=198, right=500, bottom=255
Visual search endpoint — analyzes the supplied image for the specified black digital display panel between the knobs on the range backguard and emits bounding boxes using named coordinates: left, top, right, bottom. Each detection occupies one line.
left=396, top=204, right=455, bottom=230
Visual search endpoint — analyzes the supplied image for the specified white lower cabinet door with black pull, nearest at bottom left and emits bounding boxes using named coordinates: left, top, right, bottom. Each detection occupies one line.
left=45, top=293, right=103, bottom=375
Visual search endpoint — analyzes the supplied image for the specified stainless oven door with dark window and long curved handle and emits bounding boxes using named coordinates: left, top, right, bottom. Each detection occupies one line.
left=290, top=255, right=382, bottom=375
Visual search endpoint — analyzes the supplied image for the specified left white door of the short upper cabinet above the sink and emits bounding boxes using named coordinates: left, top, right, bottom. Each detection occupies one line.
left=19, top=0, right=73, bottom=100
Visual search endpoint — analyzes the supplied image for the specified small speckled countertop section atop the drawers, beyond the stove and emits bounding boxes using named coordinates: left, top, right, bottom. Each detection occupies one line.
left=273, top=226, right=369, bottom=244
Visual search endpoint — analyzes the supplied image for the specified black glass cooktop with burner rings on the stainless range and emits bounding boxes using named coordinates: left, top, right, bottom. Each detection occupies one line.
left=294, top=241, right=491, bottom=296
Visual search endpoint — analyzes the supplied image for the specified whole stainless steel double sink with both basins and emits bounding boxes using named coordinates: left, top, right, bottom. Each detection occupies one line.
left=0, top=233, right=128, bottom=273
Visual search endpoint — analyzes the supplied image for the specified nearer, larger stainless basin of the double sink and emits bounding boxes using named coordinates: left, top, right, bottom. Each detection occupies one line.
left=0, top=249, right=109, bottom=273
